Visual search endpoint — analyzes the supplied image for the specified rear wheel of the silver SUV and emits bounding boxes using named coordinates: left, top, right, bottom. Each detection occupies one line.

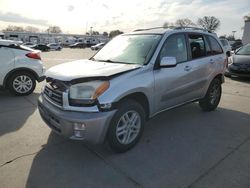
left=199, top=78, right=222, bottom=111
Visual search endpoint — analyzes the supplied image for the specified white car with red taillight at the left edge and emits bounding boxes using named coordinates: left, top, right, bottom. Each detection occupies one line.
left=0, top=39, right=45, bottom=95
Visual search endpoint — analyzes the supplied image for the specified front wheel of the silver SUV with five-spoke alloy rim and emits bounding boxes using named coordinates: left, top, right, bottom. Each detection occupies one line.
left=107, top=99, right=145, bottom=153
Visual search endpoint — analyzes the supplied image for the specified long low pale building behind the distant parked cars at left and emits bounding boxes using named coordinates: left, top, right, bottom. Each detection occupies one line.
left=0, top=31, right=108, bottom=45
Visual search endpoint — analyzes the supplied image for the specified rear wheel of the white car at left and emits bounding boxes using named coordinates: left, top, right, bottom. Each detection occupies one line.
left=8, top=72, right=36, bottom=96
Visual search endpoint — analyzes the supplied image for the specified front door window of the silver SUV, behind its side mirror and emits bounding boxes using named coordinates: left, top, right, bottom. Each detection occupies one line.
left=160, top=34, right=187, bottom=63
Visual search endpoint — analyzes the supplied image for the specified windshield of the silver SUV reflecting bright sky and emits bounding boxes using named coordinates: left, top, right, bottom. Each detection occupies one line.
left=92, top=35, right=161, bottom=65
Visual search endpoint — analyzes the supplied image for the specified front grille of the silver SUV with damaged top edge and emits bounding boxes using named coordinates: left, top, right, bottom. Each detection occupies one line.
left=44, top=80, right=67, bottom=106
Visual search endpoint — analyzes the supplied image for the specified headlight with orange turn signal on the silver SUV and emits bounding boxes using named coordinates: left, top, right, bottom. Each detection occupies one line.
left=69, top=80, right=109, bottom=106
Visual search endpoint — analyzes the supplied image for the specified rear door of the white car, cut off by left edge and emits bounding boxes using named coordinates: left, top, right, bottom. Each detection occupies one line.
left=0, top=45, right=15, bottom=85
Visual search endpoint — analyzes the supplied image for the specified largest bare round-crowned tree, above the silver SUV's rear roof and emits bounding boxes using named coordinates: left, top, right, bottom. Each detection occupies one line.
left=197, top=16, right=220, bottom=32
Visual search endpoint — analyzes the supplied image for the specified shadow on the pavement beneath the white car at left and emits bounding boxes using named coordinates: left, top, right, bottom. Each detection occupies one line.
left=0, top=90, right=39, bottom=136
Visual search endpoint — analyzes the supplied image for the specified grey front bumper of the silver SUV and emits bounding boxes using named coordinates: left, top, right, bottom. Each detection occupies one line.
left=38, top=96, right=116, bottom=144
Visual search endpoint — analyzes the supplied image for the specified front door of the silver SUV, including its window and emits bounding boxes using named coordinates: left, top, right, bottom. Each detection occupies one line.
left=154, top=33, right=197, bottom=112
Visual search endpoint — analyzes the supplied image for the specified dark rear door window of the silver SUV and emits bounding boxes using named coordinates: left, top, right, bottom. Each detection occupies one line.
left=188, top=35, right=206, bottom=59
